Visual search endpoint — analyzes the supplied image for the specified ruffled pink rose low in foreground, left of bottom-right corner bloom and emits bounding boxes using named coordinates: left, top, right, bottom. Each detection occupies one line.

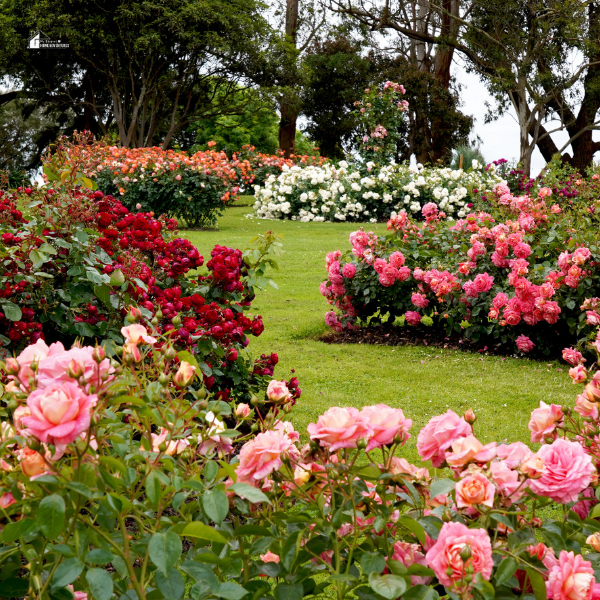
left=425, top=522, right=494, bottom=587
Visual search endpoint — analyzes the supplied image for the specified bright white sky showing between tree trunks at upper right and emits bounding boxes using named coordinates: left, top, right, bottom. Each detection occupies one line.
left=454, top=63, right=569, bottom=176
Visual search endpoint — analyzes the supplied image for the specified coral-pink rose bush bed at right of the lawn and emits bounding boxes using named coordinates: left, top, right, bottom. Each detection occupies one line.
left=321, top=184, right=600, bottom=355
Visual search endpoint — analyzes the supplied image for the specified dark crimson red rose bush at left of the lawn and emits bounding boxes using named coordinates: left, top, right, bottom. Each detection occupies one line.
left=0, top=171, right=280, bottom=402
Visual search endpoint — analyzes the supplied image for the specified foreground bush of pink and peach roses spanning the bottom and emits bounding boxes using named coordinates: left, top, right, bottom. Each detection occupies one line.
left=0, top=324, right=600, bottom=600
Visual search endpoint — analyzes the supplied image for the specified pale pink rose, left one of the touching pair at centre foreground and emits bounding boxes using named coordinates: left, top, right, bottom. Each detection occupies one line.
left=307, top=406, right=373, bottom=452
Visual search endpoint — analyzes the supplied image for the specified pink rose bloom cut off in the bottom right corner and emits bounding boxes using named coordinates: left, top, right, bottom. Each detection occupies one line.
left=546, top=550, right=596, bottom=600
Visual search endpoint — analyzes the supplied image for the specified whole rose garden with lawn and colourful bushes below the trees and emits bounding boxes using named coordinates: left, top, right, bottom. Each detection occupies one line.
left=0, top=69, right=600, bottom=600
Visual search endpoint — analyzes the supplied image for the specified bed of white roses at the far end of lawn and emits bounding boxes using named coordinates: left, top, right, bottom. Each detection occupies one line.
left=254, top=161, right=502, bottom=223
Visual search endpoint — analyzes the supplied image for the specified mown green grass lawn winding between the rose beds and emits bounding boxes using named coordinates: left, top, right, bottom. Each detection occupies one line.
left=184, top=207, right=576, bottom=460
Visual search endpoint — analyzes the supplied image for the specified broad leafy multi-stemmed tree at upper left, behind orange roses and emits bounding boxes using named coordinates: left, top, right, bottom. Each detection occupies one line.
left=0, top=0, right=281, bottom=148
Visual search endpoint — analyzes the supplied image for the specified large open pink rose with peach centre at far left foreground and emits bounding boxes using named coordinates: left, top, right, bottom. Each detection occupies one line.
left=21, top=381, right=97, bottom=451
